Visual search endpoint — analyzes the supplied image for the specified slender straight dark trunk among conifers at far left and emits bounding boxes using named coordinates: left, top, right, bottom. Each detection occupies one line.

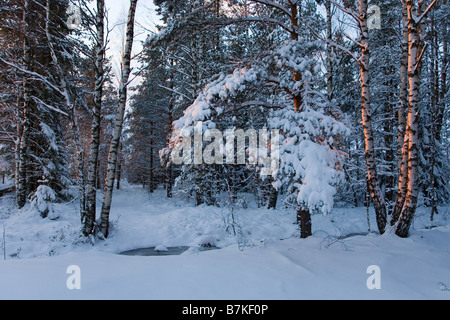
left=16, top=0, right=31, bottom=209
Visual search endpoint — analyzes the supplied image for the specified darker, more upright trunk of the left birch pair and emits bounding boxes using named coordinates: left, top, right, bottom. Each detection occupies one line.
left=83, top=0, right=105, bottom=236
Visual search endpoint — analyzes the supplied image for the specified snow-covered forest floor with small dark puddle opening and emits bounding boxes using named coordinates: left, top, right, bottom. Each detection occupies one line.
left=0, top=183, right=450, bottom=300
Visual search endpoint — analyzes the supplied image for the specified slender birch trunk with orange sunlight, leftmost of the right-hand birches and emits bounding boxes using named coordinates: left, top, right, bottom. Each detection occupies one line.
left=359, top=0, right=387, bottom=234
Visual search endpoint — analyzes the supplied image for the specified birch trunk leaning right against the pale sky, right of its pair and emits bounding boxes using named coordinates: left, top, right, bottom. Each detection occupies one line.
left=100, top=0, right=138, bottom=238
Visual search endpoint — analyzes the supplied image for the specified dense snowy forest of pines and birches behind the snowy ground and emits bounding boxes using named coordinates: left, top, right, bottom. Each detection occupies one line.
left=0, top=0, right=450, bottom=238
